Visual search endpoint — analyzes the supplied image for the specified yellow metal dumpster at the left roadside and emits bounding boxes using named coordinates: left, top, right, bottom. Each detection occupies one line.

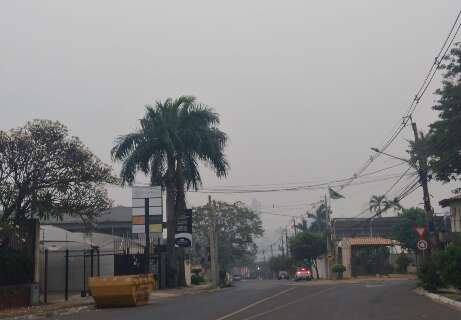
left=88, top=274, right=154, bottom=308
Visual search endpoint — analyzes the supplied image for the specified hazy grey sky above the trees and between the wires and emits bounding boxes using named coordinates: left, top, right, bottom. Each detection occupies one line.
left=0, top=0, right=460, bottom=240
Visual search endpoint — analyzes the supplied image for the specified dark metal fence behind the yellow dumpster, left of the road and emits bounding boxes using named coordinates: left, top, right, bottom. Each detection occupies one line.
left=40, top=239, right=166, bottom=303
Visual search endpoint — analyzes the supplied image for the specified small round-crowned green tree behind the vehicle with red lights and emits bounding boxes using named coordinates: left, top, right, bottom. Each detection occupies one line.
left=289, top=231, right=326, bottom=278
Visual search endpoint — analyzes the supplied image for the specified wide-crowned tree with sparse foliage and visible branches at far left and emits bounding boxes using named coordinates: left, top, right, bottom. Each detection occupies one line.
left=0, top=120, right=117, bottom=226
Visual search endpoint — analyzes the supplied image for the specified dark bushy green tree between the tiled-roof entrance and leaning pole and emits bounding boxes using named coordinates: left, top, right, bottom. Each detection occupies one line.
left=393, top=208, right=427, bottom=251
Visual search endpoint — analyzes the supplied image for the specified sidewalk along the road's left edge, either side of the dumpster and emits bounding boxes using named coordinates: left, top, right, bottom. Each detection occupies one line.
left=0, top=284, right=219, bottom=320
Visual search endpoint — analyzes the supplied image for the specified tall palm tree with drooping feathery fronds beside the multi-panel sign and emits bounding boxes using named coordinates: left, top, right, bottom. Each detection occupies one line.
left=111, top=96, right=228, bottom=286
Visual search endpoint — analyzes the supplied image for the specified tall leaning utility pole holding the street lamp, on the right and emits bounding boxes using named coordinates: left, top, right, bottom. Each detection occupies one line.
left=411, top=120, right=439, bottom=248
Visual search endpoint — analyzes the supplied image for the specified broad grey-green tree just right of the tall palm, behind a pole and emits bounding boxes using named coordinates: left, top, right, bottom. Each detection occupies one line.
left=192, top=201, right=264, bottom=270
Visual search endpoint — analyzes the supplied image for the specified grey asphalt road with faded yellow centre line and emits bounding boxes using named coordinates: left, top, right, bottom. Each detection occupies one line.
left=59, top=280, right=461, bottom=320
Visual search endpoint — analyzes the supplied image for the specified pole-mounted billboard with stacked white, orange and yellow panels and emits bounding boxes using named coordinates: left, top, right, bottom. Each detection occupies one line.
left=131, top=186, right=163, bottom=237
